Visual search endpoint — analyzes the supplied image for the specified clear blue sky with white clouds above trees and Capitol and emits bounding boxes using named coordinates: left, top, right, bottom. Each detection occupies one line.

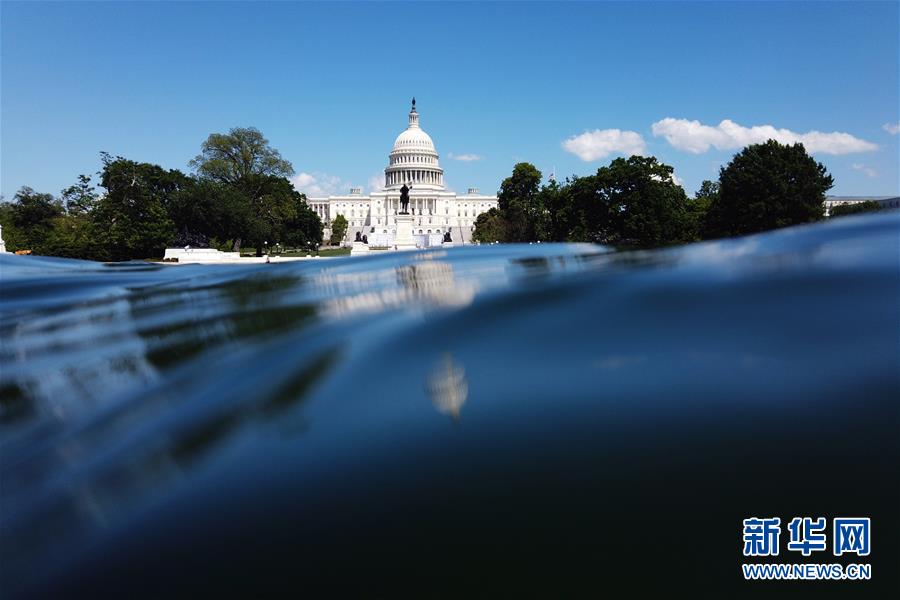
left=0, top=2, right=900, bottom=199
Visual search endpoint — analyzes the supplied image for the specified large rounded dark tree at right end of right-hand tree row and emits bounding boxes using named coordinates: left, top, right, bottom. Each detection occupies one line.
left=706, top=140, right=834, bottom=236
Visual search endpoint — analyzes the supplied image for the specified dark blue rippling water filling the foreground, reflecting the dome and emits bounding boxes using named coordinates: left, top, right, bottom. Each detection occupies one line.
left=0, top=214, right=900, bottom=597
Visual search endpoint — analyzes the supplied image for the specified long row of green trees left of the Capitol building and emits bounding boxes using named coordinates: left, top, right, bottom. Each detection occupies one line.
left=0, top=127, right=322, bottom=261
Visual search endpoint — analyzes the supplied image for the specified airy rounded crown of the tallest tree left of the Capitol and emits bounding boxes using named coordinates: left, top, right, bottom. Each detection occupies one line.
left=190, top=127, right=294, bottom=187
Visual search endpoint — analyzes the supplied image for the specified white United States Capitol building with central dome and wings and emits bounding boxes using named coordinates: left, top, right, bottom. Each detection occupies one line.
left=307, top=99, right=497, bottom=247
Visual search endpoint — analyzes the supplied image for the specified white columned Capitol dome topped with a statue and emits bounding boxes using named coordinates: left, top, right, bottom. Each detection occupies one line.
left=384, top=98, right=444, bottom=190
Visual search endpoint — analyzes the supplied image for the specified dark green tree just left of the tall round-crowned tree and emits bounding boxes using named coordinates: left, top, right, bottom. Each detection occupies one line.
left=92, top=153, right=191, bottom=260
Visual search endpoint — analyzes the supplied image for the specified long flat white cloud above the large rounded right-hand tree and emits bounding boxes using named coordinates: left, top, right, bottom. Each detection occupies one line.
left=652, top=117, right=878, bottom=154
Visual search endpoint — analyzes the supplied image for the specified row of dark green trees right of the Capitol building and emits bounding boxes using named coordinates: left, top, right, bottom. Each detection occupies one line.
left=473, top=140, right=856, bottom=249
